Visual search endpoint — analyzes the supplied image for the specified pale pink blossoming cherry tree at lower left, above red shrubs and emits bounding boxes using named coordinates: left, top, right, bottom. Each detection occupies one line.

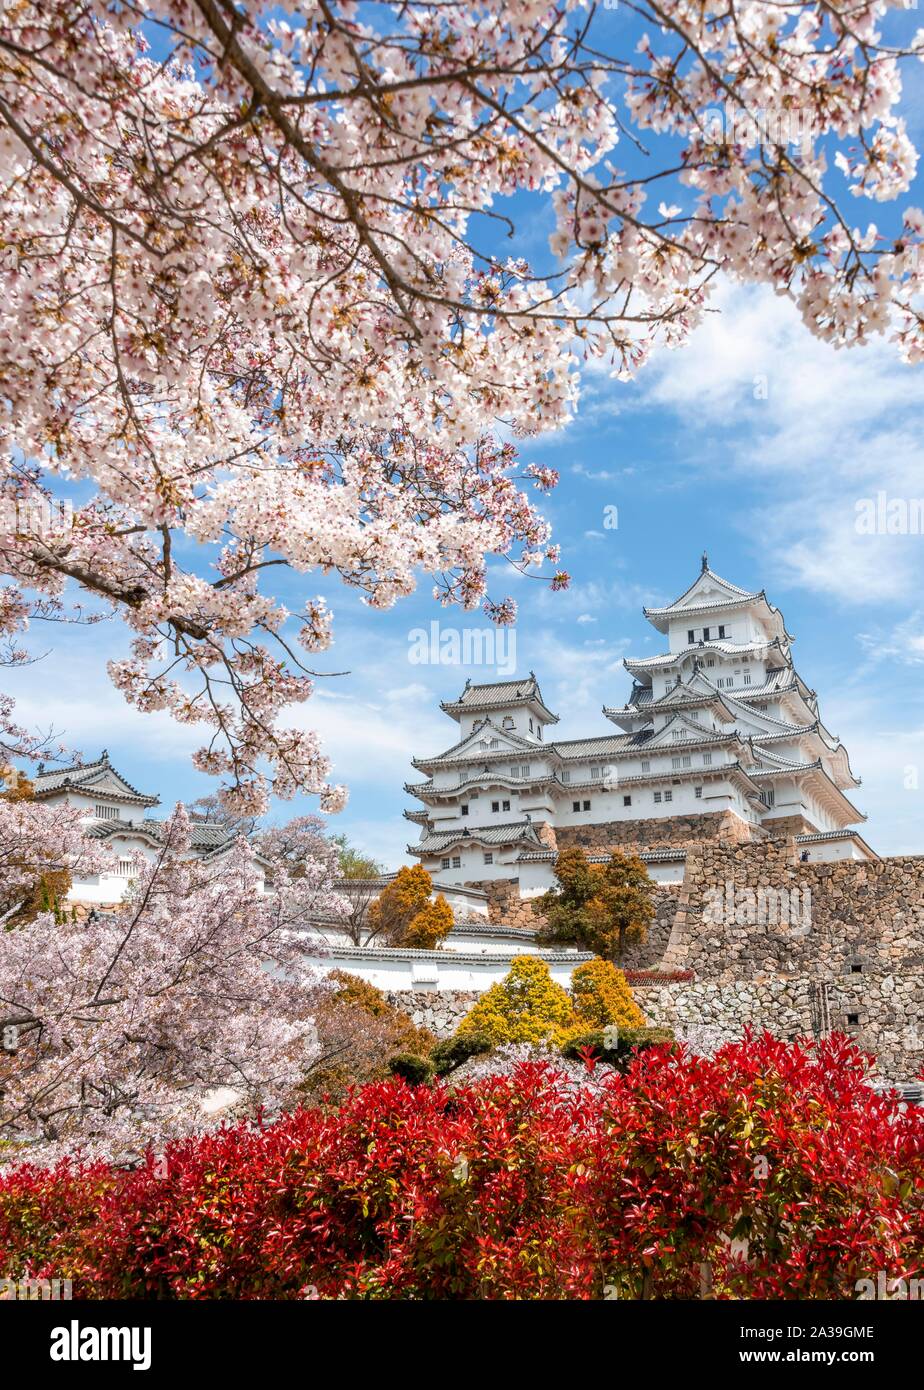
left=0, top=802, right=347, bottom=1161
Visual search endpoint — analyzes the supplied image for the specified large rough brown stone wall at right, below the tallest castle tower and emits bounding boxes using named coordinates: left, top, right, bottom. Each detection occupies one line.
left=652, top=840, right=924, bottom=1079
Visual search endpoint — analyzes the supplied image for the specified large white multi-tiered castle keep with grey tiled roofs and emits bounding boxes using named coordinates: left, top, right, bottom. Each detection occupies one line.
left=404, top=556, right=877, bottom=897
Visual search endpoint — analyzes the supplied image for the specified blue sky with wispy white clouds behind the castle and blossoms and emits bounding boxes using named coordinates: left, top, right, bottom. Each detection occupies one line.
left=3, top=11, right=924, bottom=867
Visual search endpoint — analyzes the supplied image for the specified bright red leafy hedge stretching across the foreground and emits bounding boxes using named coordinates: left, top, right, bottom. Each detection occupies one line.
left=0, top=1036, right=924, bottom=1298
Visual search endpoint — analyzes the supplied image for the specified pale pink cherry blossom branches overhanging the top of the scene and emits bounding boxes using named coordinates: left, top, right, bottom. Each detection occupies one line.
left=0, top=0, right=924, bottom=815
